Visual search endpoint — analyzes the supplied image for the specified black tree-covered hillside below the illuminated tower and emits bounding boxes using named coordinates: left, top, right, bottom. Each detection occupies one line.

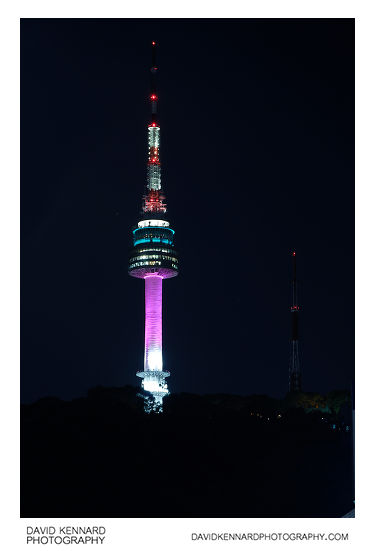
left=21, top=386, right=353, bottom=517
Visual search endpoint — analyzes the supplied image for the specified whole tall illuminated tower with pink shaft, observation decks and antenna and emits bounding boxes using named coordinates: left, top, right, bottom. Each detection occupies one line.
left=129, top=42, right=178, bottom=407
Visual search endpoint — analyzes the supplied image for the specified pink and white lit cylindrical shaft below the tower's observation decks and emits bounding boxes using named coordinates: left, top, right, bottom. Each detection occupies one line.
left=144, top=275, right=163, bottom=371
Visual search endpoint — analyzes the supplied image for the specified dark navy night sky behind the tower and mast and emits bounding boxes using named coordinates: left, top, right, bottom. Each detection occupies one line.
left=21, top=19, right=354, bottom=402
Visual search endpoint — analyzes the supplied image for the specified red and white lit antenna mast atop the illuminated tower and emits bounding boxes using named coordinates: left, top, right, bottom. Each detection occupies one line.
left=143, top=42, right=167, bottom=214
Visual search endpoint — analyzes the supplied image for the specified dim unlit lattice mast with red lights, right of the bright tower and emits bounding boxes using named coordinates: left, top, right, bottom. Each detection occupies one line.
left=289, top=251, right=302, bottom=392
